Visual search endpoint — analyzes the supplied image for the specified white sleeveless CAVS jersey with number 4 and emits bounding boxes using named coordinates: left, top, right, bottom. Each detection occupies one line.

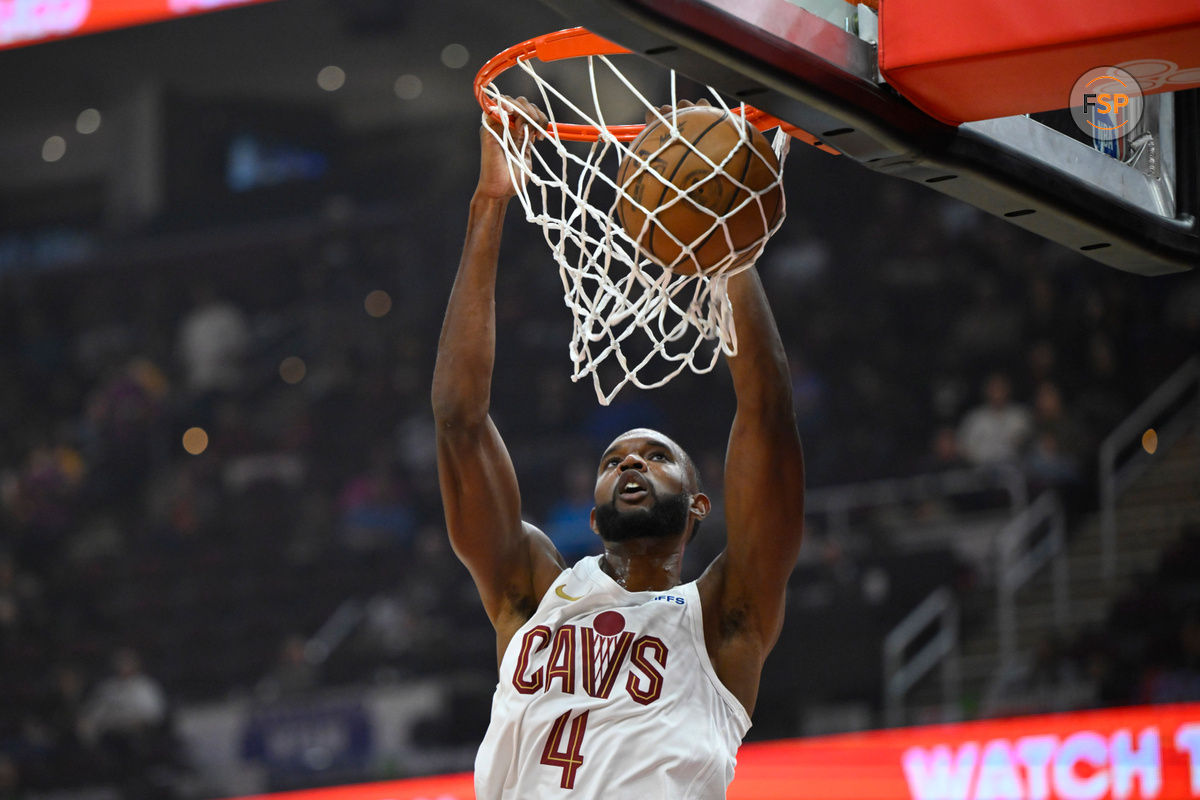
left=475, top=557, right=750, bottom=800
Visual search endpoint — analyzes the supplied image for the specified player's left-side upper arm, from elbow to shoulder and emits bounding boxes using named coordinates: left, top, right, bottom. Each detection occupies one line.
left=437, top=419, right=557, bottom=622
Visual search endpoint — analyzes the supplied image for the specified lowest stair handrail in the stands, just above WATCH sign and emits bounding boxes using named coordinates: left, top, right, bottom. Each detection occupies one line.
left=883, top=587, right=962, bottom=727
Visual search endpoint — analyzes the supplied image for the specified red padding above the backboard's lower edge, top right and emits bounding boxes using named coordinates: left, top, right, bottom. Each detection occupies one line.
left=880, top=0, right=1200, bottom=125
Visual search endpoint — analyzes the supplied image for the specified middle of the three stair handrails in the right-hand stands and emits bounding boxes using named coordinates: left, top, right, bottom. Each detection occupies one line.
left=996, top=492, right=1069, bottom=663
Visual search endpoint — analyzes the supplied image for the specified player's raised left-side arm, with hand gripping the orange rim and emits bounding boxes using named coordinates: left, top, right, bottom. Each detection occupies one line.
left=432, top=100, right=562, bottom=652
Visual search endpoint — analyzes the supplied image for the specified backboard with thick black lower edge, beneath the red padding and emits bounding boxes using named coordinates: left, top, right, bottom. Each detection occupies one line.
left=544, top=0, right=1200, bottom=275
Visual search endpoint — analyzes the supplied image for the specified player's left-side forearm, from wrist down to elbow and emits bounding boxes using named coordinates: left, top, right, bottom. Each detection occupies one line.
left=432, top=194, right=508, bottom=427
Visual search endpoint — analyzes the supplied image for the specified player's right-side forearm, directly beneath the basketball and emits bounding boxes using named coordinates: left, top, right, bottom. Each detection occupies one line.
left=728, top=269, right=792, bottom=416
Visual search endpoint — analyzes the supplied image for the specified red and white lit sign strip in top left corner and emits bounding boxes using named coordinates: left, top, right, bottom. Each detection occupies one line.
left=0, top=0, right=279, bottom=49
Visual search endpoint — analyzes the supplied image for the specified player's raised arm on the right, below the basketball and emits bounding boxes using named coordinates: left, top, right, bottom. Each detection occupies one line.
left=706, top=269, right=804, bottom=709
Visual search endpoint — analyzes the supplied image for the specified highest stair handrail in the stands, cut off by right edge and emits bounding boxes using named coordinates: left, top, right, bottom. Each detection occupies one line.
left=1099, top=356, right=1200, bottom=581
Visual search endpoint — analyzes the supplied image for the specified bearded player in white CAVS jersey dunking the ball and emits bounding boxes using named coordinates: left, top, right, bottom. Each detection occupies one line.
left=433, top=100, right=804, bottom=800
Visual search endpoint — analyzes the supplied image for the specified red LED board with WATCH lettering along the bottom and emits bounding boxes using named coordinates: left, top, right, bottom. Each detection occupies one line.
left=225, top=703, right=1200, bottom=800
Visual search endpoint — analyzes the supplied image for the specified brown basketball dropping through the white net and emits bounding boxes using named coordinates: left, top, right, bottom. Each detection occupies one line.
left=617, top=106, right=782, bottom=275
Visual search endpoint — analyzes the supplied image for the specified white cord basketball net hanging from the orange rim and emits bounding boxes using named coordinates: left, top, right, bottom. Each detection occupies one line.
left=477, top=55, right=788, bottom=405
